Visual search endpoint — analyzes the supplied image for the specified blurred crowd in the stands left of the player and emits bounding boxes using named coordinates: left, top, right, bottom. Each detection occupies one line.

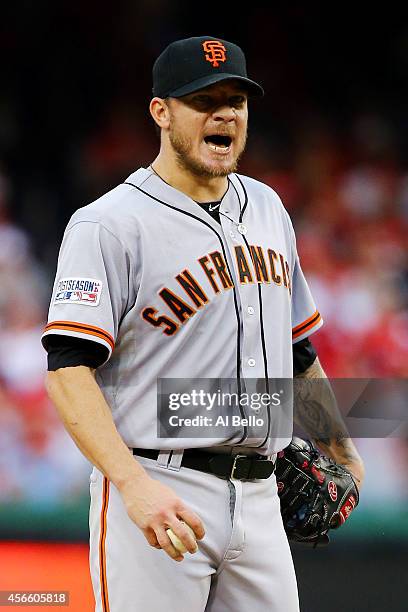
left=0, top=176, right=89, bottom=510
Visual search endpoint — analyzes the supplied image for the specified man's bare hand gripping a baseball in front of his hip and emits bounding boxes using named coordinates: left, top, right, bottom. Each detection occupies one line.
left=119, top=475, right=205, bottom=561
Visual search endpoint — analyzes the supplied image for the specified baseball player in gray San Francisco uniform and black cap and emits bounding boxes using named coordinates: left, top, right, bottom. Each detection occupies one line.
left=42, top=36, right=362, bottom=612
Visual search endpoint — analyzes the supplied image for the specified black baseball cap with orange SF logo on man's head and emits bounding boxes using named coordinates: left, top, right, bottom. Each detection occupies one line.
left=153, top=36, right=264, bottom=98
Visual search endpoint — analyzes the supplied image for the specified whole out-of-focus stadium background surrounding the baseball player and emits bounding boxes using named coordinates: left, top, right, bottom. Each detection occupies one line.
left=0, top=0, right=408, bottom=612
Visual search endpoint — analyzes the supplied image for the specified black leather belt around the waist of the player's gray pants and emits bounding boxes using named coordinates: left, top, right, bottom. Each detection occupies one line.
left=132, top=448, right=275, bottom=480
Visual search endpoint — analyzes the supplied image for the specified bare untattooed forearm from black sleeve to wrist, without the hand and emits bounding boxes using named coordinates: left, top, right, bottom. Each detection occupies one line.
left=46, top=366, right=147, bottom=489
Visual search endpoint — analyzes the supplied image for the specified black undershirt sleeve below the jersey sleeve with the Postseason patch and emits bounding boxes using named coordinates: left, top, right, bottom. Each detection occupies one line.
left=43, top=334, right=109, bottom=372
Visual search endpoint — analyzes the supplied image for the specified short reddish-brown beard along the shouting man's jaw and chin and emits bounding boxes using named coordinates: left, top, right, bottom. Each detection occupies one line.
left=169, top=125, right=247, bottom=178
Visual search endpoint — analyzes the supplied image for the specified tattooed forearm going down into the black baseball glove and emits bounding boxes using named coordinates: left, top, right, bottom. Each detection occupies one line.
left=294, top=358, right=364, bottom=482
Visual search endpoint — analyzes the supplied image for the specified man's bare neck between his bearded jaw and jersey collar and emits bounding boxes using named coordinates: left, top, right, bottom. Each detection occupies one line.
left=151, top=154, right=228, bottom=202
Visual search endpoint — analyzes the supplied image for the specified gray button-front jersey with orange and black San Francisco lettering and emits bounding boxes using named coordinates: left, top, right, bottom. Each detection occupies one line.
left=44, top=168, right=322, bottom=454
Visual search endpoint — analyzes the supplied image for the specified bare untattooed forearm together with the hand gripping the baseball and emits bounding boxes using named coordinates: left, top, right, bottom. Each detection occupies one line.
left=47, top=366, right=204, bottom=561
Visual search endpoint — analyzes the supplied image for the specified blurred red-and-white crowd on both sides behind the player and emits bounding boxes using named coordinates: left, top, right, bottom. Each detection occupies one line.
left=0, top=107, right=408, bottom=505
